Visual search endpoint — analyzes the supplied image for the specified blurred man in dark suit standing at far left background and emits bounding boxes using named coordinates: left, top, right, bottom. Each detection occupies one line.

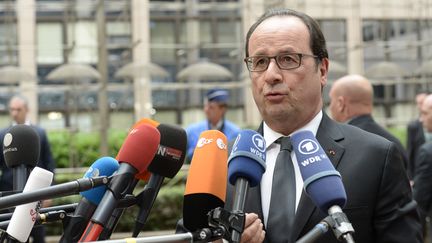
left=0, top=95, right=55, bottom=243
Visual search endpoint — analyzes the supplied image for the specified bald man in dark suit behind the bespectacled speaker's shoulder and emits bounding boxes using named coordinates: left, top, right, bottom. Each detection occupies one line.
left=329, top=75, right=408, bottom=169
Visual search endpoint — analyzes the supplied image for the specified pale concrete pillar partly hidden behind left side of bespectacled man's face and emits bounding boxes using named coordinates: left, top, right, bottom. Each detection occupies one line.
left=241, top=0, right=265, bottom=127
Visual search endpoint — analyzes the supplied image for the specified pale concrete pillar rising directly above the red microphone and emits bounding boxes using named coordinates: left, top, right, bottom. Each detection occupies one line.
left=131, top=0, right=153, bottom=121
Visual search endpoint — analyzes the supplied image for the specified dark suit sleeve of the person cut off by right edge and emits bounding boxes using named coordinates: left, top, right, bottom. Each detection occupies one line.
left=413, top=146, right=432, bottom=217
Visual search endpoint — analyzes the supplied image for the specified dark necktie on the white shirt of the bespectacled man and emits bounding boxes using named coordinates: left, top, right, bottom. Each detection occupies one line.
left=266, top=137, right=296, bottom=243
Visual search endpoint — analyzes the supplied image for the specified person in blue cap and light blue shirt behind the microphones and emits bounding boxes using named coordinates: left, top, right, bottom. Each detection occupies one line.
left=186, top=89, right=240, bottom=161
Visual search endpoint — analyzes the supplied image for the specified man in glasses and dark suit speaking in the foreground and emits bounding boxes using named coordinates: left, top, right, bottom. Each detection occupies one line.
left=230, top=9, right=422, bottom=243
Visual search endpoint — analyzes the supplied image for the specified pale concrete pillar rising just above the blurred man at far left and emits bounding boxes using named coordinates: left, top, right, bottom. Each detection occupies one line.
left=16, top=0, right=39, bottom=123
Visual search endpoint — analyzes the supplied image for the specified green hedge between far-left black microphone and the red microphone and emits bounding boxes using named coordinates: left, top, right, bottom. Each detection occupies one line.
left=48, top=131, right=127, bottom=168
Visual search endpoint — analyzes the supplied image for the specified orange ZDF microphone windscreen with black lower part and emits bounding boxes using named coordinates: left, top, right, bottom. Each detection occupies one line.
left=183, top=130, right=228, bottom=232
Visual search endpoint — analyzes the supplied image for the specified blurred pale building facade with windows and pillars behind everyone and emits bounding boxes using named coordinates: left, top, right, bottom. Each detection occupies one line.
left=0, top=0, right=432, bottom=131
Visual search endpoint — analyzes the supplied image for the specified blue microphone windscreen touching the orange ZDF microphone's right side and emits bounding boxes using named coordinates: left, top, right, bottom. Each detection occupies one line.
left=228, top=130, right=266, bottom=187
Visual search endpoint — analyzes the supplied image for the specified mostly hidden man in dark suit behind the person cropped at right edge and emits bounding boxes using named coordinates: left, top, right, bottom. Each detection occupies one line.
left=407, top=93, right=427, bottom=178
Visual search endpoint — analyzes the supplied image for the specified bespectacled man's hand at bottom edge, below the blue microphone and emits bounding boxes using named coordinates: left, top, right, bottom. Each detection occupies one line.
left=240, top=213, right=265, bottom=243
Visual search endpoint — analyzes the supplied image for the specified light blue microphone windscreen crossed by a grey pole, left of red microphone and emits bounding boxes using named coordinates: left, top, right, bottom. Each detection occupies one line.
left=80, top=157, right=119, bottom=205
